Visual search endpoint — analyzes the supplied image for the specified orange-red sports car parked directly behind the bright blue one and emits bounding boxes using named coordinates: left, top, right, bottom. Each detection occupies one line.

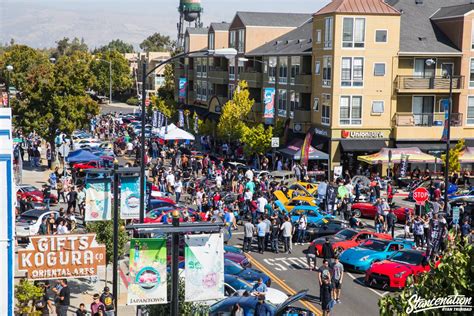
left=312, top=228, right=392, bottom=255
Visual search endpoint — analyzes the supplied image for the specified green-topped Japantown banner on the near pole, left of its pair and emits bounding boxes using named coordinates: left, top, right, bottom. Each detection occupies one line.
left=127, top=238, right=168, bottom=305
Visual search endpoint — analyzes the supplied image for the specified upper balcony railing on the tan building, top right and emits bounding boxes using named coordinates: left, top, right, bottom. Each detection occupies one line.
left=396, top=76, right=464, bottom=93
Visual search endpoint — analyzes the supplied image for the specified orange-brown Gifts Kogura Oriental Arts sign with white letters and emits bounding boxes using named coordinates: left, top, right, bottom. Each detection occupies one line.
left=18, top=234, right=105, bottom=280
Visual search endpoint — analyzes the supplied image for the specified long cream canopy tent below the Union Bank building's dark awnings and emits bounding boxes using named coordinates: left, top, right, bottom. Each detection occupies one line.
left=357, top=147, right=442, bottom=165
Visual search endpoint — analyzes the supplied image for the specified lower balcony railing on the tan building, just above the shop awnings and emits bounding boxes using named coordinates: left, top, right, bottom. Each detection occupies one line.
left=395, top=113, right=462, bottom=127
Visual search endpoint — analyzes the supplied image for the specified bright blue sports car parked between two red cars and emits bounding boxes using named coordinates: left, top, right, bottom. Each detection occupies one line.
left=339, top=238, right=415, bottom=272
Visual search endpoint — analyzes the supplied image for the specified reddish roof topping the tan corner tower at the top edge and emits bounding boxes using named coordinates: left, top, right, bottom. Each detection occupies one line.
left=314, top=0, right=400, bottom=15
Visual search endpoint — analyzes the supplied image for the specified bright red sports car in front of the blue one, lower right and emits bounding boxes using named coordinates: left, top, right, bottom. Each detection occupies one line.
left=365, top=249, right=439, bottom=290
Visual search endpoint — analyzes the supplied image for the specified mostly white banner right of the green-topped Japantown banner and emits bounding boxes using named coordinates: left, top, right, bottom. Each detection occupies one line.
left=185, top=234, right=224, bottom=302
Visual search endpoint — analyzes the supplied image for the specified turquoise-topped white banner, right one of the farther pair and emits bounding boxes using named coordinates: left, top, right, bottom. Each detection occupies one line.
left=120, top=177, right=140, bottom=219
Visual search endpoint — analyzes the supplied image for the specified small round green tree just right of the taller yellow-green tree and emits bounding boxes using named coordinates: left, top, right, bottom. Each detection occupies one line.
left=240, top=124, right=273, bottom=156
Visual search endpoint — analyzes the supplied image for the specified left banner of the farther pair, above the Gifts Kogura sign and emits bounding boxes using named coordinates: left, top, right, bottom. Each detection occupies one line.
left=84, top=179, right=112, bottom=222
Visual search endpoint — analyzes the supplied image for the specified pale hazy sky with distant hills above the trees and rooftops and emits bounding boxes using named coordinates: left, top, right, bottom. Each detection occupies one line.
left=0, top=0, right=329, bottom=48
